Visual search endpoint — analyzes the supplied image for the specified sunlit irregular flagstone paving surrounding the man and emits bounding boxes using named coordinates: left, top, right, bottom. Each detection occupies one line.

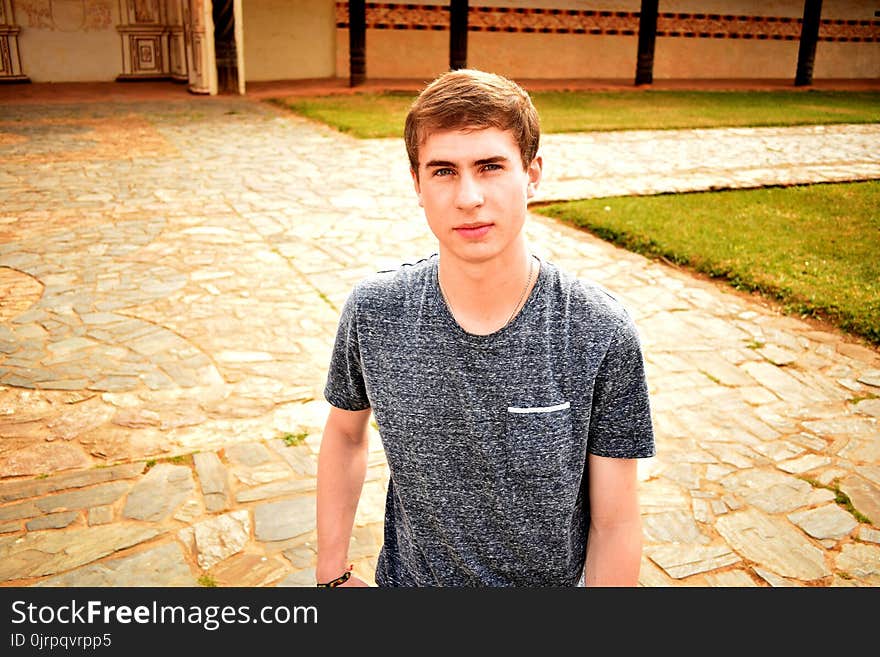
left=0, top=89, right=880, bottom=586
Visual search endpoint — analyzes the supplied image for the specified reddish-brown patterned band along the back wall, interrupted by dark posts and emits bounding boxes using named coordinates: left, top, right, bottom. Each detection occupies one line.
left=336, top=2, right=880, bottom=43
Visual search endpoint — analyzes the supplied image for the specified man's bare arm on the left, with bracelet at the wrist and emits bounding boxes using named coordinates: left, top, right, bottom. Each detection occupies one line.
left=315, top=406, right=371, bottom=586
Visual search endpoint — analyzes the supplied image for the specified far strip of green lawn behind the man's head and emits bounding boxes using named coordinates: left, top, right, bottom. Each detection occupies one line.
left=270, top=90, right=880, bottom=138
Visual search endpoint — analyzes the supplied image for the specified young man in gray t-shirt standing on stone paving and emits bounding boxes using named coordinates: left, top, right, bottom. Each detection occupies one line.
left=316, top=70, right=654, bottom=586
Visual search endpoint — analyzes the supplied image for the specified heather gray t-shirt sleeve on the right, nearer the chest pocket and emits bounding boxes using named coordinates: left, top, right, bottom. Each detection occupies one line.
left=587, top=315, right=655, bottom=458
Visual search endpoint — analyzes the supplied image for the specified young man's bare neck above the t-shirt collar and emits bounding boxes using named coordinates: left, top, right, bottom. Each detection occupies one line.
left=438, top=240, right=539, bottom=335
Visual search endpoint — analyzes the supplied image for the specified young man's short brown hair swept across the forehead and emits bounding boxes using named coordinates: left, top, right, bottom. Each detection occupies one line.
left=404, top=69, right=541, bottom=174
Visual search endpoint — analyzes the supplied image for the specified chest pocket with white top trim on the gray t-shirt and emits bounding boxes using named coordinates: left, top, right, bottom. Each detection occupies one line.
left=505, top=402, right=572, bottom=479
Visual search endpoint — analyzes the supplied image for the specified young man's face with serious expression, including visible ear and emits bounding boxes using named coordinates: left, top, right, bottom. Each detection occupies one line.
left=413, top=128, right=541, bottom=263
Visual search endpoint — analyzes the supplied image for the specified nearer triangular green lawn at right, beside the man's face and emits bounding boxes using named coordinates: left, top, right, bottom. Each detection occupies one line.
left=531, top=181, right=880, bottom=345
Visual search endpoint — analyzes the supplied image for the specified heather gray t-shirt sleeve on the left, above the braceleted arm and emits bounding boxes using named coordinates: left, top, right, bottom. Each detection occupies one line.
left=324, top=287, right=370, bottom=411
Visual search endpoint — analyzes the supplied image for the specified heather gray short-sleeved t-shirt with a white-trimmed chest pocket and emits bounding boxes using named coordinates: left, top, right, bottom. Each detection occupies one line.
left=324, top=254, right=654, bottom=586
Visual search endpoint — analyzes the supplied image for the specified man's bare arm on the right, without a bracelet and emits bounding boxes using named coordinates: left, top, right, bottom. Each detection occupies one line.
left=584, top=454, right=642, bottom=586
